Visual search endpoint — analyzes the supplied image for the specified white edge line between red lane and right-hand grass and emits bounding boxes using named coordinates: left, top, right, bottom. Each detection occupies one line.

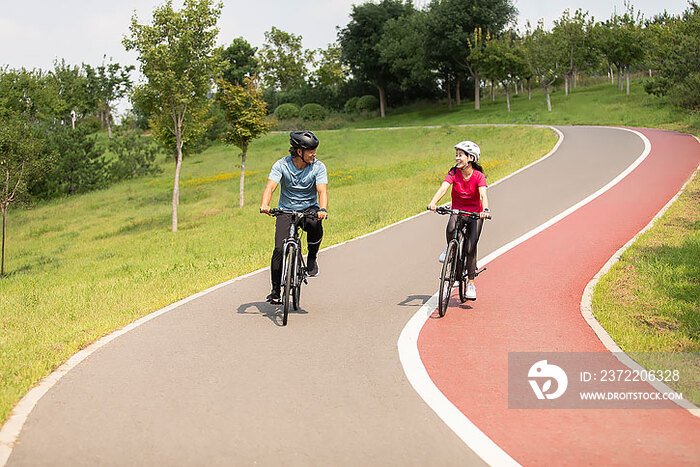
left=581, top=164, right=700, bottom=417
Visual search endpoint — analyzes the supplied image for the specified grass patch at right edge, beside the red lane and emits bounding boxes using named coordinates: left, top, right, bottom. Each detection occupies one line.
left=593, top=176, right=700, bottom=404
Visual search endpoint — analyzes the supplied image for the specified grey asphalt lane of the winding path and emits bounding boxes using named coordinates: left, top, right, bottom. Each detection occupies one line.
left=8, top=127, right=656, bottom=466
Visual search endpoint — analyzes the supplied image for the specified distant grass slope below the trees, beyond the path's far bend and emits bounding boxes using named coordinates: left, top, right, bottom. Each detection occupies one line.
left=350, top=80, right=700, bottom=134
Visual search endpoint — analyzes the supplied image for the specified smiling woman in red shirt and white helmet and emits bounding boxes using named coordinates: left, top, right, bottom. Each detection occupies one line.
left=428, top=141, right=489, bottom=300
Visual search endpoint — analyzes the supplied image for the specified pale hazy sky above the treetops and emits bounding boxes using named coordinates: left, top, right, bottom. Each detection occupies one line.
left=0, top=0, right=688, bottom=74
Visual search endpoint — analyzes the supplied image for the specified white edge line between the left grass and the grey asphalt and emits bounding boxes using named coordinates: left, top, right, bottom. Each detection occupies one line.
left=0, top=125, right=564, bottom=467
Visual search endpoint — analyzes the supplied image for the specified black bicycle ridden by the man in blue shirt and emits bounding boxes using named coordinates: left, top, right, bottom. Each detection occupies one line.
left=270, top=208, right=317, bottom=326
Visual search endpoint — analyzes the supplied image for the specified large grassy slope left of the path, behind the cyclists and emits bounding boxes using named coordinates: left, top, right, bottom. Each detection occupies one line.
left=0, top=126, right=556, bottom=420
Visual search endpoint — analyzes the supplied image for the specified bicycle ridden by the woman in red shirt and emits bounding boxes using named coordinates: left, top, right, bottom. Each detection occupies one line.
left=435, top=206, right=491, bottom=318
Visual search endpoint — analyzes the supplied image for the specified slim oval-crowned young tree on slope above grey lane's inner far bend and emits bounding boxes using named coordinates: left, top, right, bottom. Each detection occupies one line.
left=525, top=20, right=561, bottom=112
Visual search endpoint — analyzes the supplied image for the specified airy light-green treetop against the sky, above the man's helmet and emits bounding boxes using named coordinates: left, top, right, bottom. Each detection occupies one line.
left=260, top=26, right=313, bottom=90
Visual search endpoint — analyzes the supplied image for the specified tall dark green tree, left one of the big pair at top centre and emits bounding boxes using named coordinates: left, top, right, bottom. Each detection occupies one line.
left=338, top=0, right=414, bottom=118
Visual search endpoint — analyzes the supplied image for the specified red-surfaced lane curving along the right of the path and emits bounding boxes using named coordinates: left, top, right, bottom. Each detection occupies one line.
left=418, top=129, right=700, bottom=465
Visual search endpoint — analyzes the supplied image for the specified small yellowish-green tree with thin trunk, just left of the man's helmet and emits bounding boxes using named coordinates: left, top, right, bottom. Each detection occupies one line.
left=216, top=77, right=272, bottom=208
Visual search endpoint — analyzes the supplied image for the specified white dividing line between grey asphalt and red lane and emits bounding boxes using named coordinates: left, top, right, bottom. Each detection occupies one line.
left=398, top=128, right=651, bottom=465
